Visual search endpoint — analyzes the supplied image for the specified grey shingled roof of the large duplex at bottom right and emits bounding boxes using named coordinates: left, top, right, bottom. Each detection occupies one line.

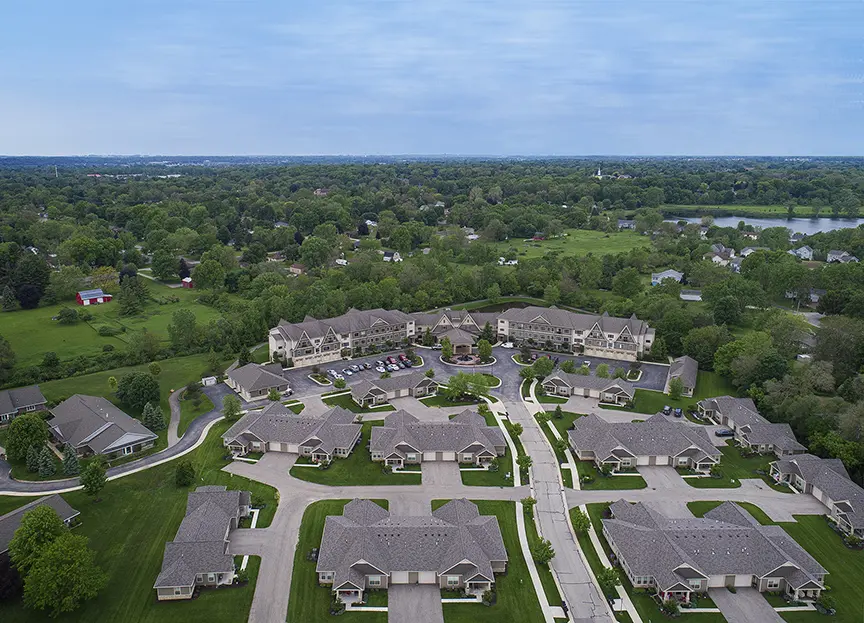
left=603, top=500, right=827, bottom=591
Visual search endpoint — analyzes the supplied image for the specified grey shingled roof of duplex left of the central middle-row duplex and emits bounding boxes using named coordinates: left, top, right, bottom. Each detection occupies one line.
left=222, top=402, right=362, bottom=454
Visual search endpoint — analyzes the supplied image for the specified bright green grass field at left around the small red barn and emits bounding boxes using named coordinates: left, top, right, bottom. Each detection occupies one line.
left=2, top=280, right=223, bottom=366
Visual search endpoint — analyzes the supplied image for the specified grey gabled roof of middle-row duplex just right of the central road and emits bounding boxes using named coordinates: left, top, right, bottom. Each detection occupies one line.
left=568, top=413, right=720, bottom=462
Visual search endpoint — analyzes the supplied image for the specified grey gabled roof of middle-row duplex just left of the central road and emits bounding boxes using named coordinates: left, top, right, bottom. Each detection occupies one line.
left=369, top=409, right=507, bottom=456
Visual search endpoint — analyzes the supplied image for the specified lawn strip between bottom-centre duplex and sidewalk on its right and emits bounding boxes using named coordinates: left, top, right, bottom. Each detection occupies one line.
left=430, top=500, right=543, bottom=623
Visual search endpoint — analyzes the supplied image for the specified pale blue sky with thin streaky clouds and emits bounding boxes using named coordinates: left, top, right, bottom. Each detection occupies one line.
left=0, top=0, right=864, bottom=156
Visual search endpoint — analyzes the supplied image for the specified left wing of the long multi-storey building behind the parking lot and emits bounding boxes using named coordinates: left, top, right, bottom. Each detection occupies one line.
left=270, top=309, right=414, bottom=366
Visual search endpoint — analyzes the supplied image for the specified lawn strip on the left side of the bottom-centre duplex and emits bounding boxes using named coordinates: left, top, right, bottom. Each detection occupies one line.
left=287, top=500, right=387, bottom=623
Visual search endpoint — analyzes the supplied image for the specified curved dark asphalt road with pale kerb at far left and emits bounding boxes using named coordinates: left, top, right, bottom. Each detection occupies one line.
left=0, top=384, right=232, bottom=495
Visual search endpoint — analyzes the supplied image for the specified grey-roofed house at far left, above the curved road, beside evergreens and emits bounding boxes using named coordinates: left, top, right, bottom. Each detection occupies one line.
left=48, top=394, right=158, bottom=459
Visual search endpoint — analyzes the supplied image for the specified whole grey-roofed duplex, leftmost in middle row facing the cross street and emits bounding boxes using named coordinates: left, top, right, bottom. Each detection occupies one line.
left=222, top=402, right=363, bottom=461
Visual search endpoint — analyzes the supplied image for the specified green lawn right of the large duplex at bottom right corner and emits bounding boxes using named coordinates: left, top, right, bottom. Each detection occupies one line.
left=687, top=502, right=864, bottom=623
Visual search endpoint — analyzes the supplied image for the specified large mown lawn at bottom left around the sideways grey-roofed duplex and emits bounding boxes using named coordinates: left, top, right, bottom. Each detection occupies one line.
left=0, top=422, right=277, bottom=623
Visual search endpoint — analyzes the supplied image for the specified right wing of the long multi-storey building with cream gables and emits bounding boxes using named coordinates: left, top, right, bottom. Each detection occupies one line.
left=498, top=306, right=654, bottom=361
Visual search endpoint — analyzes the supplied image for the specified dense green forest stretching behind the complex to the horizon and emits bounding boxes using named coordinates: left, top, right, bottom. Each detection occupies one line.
left=0, top=159, right=864, bottom=476
